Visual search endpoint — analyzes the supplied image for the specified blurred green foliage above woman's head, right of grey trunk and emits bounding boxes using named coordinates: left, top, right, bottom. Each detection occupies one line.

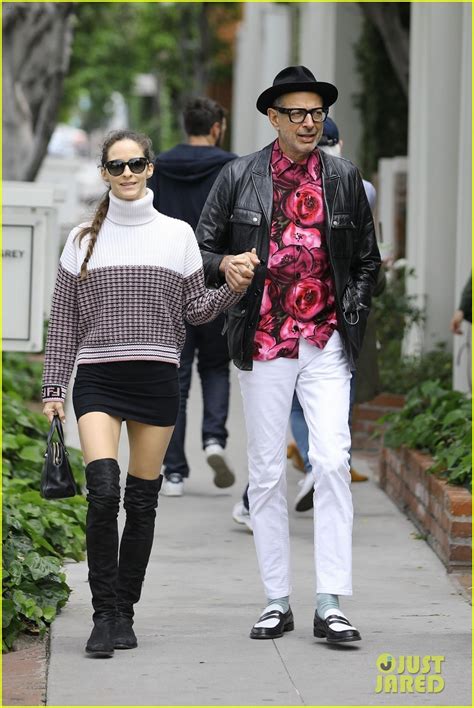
left=61, top=2, right=240, bottom=150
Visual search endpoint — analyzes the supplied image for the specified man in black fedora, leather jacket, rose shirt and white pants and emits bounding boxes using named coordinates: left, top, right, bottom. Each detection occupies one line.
left=196, top=66, right=380, bottom=643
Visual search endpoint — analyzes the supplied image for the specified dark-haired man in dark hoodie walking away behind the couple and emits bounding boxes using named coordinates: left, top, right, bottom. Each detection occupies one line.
left=149, top=97, right=237, bottom=497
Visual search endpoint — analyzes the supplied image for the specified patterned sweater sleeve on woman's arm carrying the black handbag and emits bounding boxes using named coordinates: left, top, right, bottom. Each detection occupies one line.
left=42, top=231, right=79, bottom=402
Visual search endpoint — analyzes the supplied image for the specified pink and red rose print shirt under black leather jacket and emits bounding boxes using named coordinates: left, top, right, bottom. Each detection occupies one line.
left=253, top=140, right=337, bottom=361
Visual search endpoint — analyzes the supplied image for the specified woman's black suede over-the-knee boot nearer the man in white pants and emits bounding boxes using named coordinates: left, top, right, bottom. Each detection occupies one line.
left=115, top=475, right=163, bottom=649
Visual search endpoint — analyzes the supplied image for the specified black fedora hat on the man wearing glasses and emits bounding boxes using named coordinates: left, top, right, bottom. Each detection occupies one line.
left=257, top=66, right=338, bottom=115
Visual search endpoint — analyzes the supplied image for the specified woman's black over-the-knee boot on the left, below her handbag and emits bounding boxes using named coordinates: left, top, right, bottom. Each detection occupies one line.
left=86, top=458, right=120, bottom=656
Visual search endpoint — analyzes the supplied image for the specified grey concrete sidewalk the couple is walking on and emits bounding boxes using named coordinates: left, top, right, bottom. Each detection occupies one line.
left=47, top=368, right=471, bottom=706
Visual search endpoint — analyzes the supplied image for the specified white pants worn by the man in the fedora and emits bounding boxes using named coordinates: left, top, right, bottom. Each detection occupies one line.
left=238, top=331, right=353, bottom=599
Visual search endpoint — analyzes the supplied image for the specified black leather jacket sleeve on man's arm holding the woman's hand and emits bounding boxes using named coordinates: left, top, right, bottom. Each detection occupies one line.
left=196, top=161, right=233, bottom=288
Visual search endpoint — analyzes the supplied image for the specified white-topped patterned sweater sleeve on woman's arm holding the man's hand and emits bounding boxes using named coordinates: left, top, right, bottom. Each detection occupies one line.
left=183, top=228, right=243, bottom=325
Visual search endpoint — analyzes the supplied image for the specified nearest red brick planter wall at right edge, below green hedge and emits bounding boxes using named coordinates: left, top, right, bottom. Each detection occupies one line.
left=379, top=448, right=472, bottom=572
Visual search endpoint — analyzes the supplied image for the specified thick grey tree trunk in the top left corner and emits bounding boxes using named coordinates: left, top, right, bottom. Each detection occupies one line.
left=2, top=2, right=74, bottom=181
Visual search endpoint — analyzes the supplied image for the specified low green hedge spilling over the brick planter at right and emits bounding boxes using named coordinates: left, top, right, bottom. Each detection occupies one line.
left=381, top=380, right=472, bottom=492
